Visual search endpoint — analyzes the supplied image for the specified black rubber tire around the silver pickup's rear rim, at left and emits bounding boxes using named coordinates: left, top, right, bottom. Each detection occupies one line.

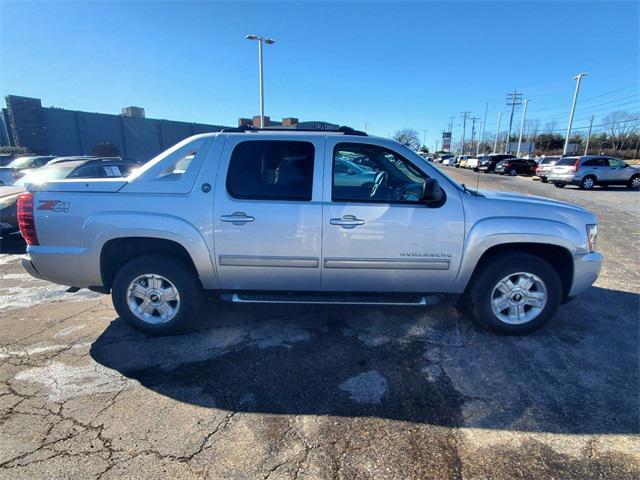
left=111, top=255, right=204, bottom=335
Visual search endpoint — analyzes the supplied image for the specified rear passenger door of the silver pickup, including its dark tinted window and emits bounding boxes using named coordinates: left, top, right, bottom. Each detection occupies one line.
left=213, top=137, right=325, bottom=291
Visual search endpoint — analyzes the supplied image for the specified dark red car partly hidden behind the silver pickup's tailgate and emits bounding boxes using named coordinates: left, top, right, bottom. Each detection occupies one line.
left=0, top=158, right=139, bottom=236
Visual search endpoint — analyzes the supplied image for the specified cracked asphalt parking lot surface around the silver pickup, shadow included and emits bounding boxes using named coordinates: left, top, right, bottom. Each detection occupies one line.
left=0, top=167, right=640, bottom=479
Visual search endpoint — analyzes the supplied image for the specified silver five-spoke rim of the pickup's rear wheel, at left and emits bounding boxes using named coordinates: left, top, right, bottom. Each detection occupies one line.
left=127, top=273, right=180, bottom=325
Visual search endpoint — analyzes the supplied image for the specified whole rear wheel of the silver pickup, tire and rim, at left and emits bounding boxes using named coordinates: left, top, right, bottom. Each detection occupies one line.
left=111, top=256, right=203, bottom=335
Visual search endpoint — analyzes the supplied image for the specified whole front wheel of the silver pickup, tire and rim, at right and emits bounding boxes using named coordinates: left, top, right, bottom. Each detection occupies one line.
left=463, top=253, right=562, bottom=335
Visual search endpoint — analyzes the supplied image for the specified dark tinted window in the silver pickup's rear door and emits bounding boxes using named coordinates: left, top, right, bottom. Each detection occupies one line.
left=226, top=140, right=315, bottom=201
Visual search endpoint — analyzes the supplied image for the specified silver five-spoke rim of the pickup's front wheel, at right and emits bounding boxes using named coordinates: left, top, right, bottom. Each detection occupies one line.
left=491, top=272, right=547, bottom=325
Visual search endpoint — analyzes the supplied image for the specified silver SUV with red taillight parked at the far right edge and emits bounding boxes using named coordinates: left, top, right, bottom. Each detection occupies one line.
left=549, top=155, right=640, bottom=190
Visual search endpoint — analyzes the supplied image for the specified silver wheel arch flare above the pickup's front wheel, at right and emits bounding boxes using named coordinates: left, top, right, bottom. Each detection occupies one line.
left=452, top=217, right=589, bottom=293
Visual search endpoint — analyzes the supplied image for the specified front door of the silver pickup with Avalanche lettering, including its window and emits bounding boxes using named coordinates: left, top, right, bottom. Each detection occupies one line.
left=322, top=140, right=464, bottom=293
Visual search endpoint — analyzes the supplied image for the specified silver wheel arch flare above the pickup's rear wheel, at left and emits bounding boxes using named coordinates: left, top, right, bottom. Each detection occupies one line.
left=82, top=212, right=220, bottom=289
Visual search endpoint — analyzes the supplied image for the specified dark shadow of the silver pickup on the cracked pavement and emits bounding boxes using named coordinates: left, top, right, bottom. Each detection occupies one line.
left=91, top=288, right=639, bottom=434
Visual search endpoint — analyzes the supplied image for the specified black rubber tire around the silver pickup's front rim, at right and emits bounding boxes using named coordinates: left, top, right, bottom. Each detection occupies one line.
left=461, top=253, right=562, bottom=335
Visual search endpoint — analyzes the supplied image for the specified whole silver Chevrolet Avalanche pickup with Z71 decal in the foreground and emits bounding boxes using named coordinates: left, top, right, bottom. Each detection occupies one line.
left=18, top=128, right=602, bottom=334
